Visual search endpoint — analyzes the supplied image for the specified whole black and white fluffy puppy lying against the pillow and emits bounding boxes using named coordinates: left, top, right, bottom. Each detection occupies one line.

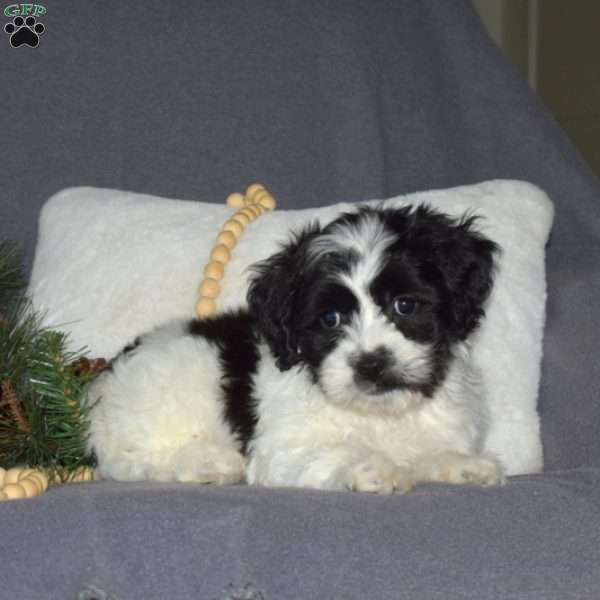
left=88, top=206, right=504, bottom=493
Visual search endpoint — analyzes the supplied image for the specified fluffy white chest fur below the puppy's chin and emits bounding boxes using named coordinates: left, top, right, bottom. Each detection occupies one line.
left=248, top=348, right=487, bottom=487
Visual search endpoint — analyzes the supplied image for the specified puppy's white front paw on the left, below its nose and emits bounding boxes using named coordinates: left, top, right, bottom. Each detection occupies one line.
left=348, top=454, right=415, bottom=494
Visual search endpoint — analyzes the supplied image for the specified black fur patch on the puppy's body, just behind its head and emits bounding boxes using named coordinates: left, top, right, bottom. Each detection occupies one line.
left=188, top=310, right=259, bottom=454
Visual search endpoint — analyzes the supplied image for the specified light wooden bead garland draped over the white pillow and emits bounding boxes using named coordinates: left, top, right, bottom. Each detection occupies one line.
left=196, top=183, right=277, bottom=318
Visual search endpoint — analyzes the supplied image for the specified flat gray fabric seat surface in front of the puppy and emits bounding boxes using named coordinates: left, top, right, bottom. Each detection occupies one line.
left=0, top=469, right=600, bottom=600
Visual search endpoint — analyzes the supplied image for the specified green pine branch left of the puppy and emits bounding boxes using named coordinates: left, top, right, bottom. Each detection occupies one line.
left=0, top=244, right=95, bottom=480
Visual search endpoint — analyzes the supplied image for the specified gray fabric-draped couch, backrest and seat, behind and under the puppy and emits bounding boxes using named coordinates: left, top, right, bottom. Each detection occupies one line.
left=0, top=0, right=600, bottom=600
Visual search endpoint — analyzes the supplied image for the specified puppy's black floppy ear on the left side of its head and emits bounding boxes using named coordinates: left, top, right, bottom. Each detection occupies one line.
left=247, top=223, right=321, bottom=371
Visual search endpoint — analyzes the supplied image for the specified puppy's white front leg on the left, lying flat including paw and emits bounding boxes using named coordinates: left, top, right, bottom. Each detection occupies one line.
left=248, top=446, right=415, bottom=494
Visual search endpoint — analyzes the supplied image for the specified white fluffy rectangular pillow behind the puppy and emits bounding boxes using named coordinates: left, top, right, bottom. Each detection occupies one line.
left=29, top=180, right=553, bottom=474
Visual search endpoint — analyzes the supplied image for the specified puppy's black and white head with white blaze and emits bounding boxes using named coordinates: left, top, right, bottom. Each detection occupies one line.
left=248, top=206, right=497, bottom=409
